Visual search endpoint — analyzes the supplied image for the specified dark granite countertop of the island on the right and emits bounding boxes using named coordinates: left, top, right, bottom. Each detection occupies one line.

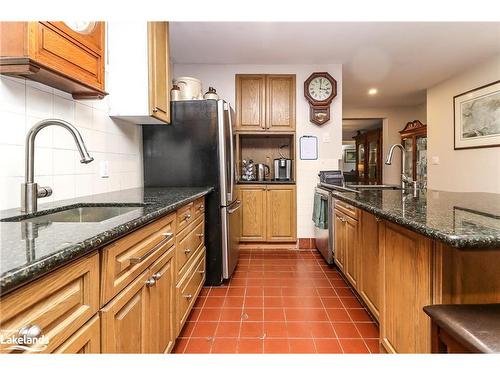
left=332, top=189, right=500, bottom=249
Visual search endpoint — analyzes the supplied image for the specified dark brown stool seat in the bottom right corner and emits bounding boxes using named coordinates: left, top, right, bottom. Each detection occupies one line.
left=424, top=303, right=500, bottom=353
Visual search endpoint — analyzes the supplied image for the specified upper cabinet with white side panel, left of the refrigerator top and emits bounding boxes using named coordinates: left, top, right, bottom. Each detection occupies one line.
left=106, top=21, right=172, bottom=125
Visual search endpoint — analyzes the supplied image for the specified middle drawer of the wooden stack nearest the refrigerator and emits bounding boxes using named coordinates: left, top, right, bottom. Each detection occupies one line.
left=176, top=214, right=205, bottom=276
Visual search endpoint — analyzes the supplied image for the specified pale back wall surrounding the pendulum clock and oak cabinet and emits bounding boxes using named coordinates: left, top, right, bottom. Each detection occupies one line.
left=174, top=64, right=342, bottom=238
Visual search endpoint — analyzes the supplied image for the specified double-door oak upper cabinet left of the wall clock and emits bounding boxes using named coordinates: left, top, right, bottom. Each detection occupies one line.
left=236, top=74, right=295, bottom=132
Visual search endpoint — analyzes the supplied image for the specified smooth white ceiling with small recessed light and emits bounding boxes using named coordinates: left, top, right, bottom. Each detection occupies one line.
left=170, top=22, right=500, bottom=107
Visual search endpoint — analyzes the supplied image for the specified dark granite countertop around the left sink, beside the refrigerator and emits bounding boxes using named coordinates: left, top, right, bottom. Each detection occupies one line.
left=0, top=187, right=213, bottom=294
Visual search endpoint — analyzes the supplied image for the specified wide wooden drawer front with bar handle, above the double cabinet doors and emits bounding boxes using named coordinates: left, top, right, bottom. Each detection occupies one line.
left=101, top=213, right=176, bottom=305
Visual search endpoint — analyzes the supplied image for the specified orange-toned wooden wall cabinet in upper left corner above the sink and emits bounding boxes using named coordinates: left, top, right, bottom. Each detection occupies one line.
left=0, top=21, right=106, bottom=99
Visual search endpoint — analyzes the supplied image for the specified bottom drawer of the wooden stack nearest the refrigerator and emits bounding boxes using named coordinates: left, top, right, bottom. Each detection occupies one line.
left=176, top=248, right=205, bottom=333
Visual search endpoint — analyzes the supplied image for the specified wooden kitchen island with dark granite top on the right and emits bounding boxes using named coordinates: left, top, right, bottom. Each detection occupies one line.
left=332, top=189, right=500, bottom=353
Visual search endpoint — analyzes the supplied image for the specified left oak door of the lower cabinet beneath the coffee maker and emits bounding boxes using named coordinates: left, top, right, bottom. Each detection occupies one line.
left=240, top=185, right=267, bottom=241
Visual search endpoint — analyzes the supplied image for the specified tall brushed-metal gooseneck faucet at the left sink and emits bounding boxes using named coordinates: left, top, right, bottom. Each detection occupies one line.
left=21, top=119, right=94, bottom=213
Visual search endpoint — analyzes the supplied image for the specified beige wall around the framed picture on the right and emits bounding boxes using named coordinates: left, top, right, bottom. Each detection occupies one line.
left=427, top=55, right=500, bottom=193
